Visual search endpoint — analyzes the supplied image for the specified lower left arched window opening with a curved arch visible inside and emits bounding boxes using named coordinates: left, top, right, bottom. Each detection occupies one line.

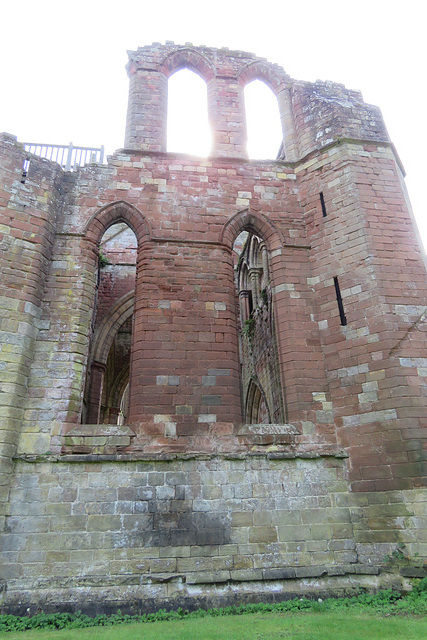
left=82, top=222, right=137, bottom=424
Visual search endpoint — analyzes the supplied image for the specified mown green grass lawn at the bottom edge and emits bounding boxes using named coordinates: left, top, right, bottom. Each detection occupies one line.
left=0, top=610, right=427, bottom=640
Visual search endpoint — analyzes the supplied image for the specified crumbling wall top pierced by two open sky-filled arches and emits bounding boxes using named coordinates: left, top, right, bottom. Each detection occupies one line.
left=125, top=42, right=389, bottom=161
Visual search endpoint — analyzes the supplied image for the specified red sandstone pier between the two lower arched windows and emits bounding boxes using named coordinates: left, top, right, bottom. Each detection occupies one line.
left=128, top=241, right=241, bottom=428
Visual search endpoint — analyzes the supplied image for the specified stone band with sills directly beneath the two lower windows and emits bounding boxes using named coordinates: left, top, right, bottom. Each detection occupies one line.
left=51, top=420, right=347, bottom=461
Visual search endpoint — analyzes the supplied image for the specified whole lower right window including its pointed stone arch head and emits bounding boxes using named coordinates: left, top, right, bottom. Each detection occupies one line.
left=227, top=209, right=286, bottom=424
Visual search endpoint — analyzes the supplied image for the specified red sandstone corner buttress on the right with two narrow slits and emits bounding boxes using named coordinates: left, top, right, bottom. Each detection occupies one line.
left=301, top=146, right=427, bottom=490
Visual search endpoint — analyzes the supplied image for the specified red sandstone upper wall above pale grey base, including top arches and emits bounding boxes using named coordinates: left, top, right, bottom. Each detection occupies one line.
left=2, top=46, right=427, bottom=490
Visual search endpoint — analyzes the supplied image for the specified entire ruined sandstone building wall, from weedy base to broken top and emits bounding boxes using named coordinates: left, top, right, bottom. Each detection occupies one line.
left=0, top=43, right=427, bottom=613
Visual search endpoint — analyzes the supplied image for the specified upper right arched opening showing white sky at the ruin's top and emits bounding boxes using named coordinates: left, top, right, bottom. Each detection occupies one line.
left=244, top=80, right=283, bottom=160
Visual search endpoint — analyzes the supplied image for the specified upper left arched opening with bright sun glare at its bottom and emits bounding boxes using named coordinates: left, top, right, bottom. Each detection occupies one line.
left=167, top=69, right=212, bottom=156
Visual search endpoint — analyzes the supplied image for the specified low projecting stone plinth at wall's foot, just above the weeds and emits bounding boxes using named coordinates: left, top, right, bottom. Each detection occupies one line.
left=2, top=574, right=405, bottom=616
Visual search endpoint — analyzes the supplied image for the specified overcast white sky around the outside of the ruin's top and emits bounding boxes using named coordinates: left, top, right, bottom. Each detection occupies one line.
left=0, top=0, right=427, bottom=246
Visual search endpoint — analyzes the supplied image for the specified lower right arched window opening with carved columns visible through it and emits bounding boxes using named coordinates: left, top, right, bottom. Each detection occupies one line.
left=233, top=230, right=284, bottom=424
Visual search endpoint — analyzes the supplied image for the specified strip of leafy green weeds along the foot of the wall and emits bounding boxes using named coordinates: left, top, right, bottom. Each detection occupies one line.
left=0, top=578, right=427, bottom=632
